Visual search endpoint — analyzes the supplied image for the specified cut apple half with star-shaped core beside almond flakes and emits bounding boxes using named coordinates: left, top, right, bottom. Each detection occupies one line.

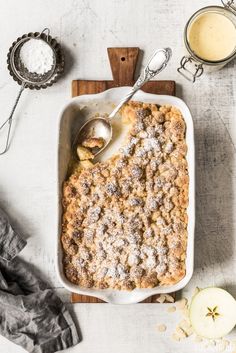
left=189, top=287, right=236, bottom=339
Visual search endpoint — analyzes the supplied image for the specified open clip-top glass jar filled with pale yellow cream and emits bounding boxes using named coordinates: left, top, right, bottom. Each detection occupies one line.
left=178, top=6, right=236, bottom=82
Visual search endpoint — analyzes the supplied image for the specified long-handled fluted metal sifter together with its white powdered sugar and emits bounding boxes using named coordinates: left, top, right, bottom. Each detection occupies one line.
left=0, top=28, right=65, bottom=155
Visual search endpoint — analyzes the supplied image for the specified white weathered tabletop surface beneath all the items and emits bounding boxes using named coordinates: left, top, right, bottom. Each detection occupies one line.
left=0, top=0, right=236, bottom=353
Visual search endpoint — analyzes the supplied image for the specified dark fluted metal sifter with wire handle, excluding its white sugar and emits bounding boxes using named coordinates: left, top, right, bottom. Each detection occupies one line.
left=0, top=28, right=65, bottom=155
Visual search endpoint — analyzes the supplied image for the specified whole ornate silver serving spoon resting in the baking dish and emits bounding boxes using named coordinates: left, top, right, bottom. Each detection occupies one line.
left=73, top=48, right=172, bottom=158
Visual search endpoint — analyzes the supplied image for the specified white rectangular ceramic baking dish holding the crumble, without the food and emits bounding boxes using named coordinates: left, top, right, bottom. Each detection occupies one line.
left=56, top=87, right=195, bottom=304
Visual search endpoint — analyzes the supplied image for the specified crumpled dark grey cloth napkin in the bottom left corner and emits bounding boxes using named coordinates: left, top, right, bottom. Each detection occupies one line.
left=0, top=209, right=79, bottom=353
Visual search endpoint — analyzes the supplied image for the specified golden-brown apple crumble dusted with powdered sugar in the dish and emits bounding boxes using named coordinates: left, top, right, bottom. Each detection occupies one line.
left=61, top=102, right=189, bottom=290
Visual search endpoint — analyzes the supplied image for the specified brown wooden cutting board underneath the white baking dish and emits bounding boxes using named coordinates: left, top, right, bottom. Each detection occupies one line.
left=71, top=48, right=175, bottom=303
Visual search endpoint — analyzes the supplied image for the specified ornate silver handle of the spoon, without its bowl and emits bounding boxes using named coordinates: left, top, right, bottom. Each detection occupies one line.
left=109, top=48, right=172, bottom=119
